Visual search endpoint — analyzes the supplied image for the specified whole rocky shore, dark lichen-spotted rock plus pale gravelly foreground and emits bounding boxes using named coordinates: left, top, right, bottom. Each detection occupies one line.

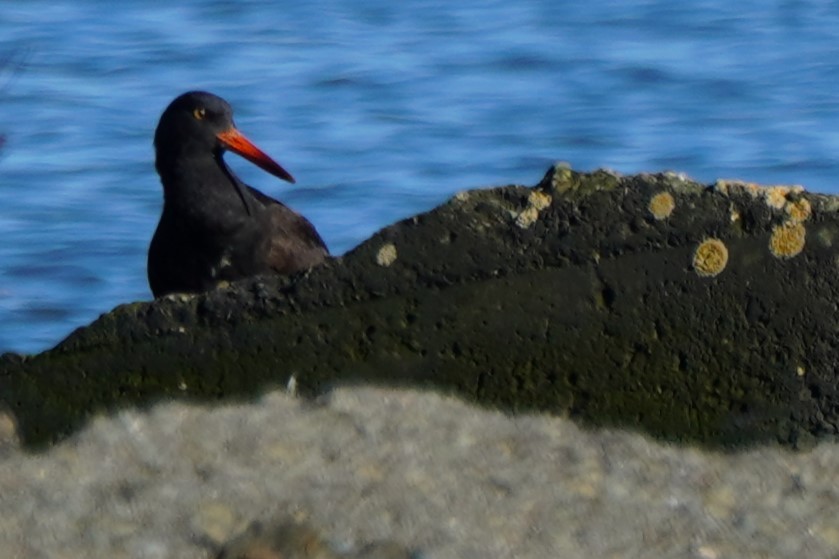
left=0, top=166, right=839, bottom=559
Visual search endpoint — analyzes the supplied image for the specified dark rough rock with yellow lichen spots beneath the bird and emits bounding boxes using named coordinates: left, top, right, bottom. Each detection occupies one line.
left=0, top=167, right=839, bottom=446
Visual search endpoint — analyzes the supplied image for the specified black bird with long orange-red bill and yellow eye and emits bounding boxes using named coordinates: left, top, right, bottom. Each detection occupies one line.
left=148, top=91, right=329, bottom=297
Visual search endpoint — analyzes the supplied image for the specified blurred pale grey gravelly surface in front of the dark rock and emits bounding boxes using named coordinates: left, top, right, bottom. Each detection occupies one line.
left=0, top=388, right=839, bottom=559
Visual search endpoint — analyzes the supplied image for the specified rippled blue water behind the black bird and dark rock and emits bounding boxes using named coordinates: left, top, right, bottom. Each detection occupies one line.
left=0, top=0, right=839, bottom=352
